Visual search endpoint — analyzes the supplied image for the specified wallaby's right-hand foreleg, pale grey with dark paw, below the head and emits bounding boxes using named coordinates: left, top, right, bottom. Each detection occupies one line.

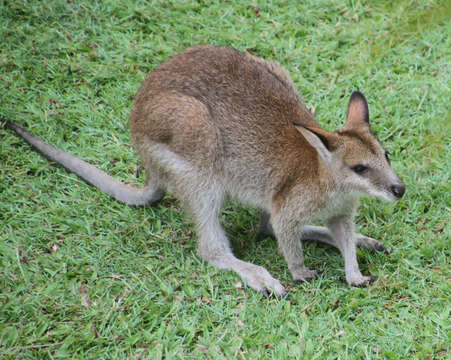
left=328, top=216, right=377, bottom=287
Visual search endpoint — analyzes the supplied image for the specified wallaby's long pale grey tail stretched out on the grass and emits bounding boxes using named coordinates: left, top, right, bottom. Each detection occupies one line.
left=0, top=119, right=162, bottom=205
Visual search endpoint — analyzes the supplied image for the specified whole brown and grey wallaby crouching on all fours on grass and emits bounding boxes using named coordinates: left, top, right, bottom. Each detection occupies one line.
left=2, top=46, right=405, bottom=295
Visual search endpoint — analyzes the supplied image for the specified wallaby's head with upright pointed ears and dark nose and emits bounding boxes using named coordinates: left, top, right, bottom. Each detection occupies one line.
left=295, top=91, right=405, bottom=201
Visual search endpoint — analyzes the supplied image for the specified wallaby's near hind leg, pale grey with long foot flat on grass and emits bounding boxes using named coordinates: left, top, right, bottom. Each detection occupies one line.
left=145, top=144, right=285, bottom=296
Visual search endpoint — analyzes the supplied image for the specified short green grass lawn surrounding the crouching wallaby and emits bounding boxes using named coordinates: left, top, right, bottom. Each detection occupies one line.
left=0, top=0, right=451, bottom=359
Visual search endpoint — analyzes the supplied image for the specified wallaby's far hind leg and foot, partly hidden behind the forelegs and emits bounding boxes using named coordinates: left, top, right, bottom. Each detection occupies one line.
left=260, top=212, right=390, bottom=254
